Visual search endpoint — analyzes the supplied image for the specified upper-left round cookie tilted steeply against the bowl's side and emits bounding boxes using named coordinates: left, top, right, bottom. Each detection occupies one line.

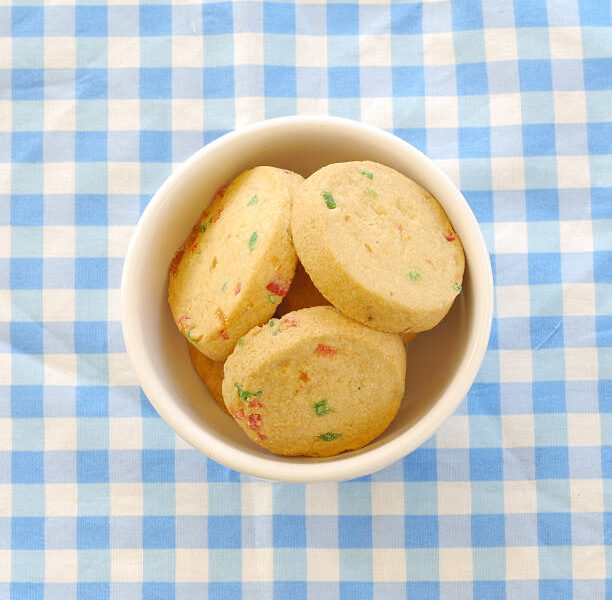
left=168, top=167, right=302, bottom=361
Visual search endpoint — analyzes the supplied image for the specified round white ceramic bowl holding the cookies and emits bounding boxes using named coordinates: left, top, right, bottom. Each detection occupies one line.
left=121, top=117, right=493, bottom=482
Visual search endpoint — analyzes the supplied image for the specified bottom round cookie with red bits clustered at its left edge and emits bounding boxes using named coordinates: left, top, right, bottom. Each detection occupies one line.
left=223, top=306, right=406, bottom=456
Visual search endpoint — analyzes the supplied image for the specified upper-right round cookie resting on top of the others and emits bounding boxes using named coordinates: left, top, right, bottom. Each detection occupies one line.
left=291, top=161, right=465, bottom=333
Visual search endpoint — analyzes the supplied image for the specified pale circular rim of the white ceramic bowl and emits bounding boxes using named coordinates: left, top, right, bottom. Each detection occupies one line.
left=121, top=116, right=494, bottom=483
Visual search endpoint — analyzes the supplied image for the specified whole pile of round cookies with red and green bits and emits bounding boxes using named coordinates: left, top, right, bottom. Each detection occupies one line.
left=169, top=161, right=465, bottom=457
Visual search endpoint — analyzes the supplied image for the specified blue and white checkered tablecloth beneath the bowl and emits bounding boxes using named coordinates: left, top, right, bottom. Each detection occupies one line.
left=0, top=0, right=612, bottom=600
